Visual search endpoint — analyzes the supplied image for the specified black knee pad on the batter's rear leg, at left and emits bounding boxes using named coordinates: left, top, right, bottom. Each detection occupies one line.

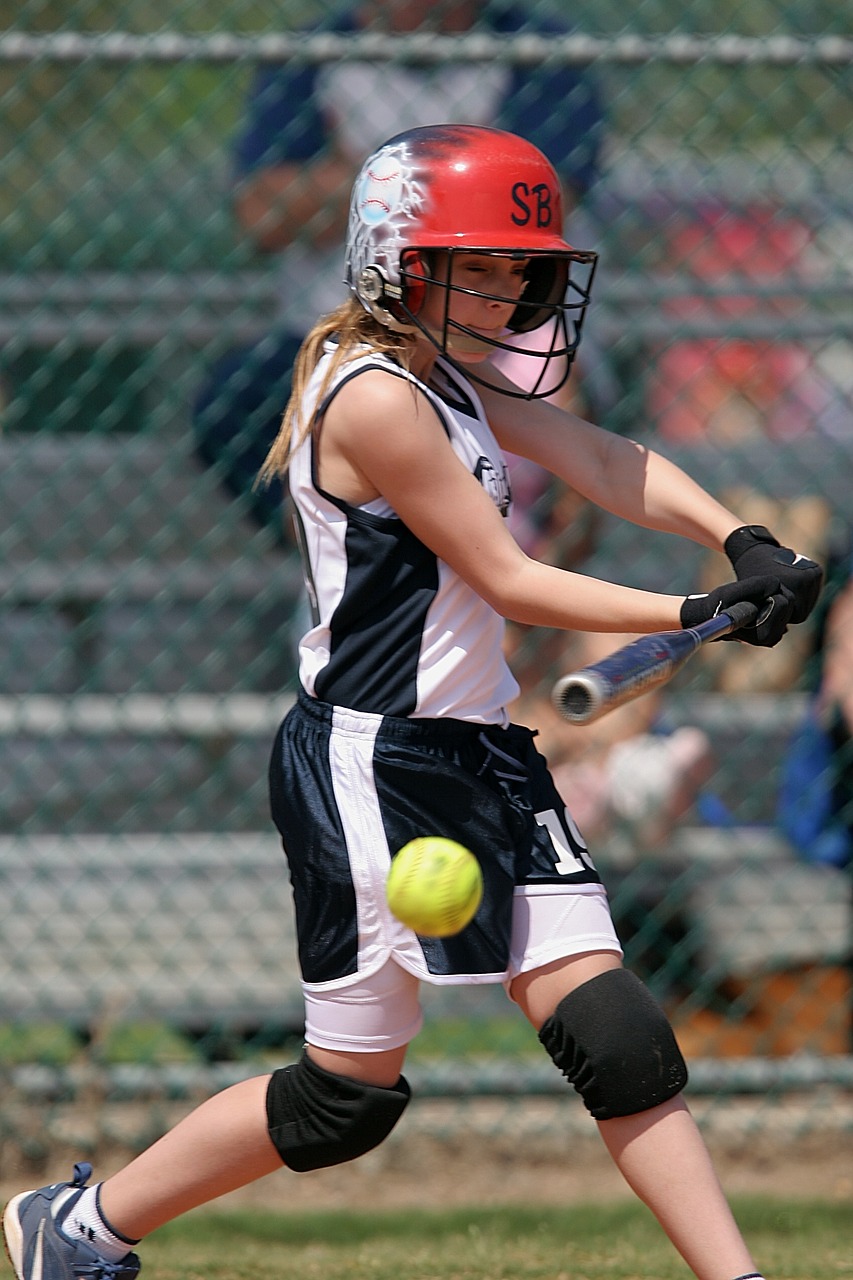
left=266, top=1053, right=411, bottom=1174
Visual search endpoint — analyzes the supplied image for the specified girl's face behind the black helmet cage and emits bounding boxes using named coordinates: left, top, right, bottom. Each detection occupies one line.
left=419, top=253, right=528, bottom=364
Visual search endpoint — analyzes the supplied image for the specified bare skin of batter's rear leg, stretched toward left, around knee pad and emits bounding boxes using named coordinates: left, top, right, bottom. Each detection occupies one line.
left=100, top=1047, right=406, bottom=1240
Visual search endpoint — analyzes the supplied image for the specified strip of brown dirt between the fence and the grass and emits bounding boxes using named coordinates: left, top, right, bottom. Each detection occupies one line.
left=0, top=1092, right=853, bottom=1213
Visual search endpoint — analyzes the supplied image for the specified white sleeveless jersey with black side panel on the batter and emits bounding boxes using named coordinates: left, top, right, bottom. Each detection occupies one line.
left=289, top=347, right=519, bottom=724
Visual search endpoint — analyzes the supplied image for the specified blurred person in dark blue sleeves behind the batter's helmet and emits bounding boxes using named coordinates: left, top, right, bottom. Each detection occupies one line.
left=193, top=0, right=603, bottom=532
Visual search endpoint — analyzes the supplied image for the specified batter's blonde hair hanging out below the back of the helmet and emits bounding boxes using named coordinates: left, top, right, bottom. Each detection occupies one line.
left=256, top=298, right=415, bottom=485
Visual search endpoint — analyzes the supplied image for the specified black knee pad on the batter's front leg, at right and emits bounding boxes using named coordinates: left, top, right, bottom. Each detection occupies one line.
left=539, top=969, right=688, bottom=1120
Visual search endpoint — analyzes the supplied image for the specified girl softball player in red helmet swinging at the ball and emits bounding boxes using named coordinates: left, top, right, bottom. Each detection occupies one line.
left=4, top=125, right=821, bottom=1280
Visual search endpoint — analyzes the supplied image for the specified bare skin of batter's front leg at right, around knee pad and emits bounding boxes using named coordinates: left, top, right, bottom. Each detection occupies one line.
left=511, top=951, right=756, bottom=1280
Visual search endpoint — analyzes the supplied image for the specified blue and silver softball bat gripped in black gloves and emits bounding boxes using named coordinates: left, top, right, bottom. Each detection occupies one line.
left=551, top=600, right=760, bottom=724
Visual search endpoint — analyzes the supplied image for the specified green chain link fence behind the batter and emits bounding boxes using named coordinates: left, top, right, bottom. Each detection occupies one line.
left=0, top=0, right=853, bottom=1162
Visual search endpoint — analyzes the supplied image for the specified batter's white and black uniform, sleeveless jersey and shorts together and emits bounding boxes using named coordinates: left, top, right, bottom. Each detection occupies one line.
left=269, top=353, right=607, bottom=988
